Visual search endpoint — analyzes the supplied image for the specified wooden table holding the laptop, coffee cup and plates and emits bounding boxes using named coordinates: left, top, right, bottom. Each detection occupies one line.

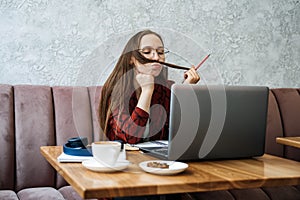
left=41, top=146, right=300, bottom=198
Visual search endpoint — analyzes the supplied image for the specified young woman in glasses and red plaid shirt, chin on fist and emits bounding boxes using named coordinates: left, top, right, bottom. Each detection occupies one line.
left=99, top=30, right=200, bottom=144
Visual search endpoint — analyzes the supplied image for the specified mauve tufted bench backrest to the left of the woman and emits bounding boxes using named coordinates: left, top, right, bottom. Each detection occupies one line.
left=0, top=85, right=103, bottom=191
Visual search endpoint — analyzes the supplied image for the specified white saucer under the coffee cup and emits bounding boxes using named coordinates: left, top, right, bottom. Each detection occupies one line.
left=82, top=158, right=130, bottom=172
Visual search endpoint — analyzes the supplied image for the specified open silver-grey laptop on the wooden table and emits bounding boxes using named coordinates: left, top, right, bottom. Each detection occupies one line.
left=143, top=84, right=269, bottom=160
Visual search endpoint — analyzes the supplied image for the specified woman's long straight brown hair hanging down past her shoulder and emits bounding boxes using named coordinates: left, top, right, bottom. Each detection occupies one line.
left=99, top=30, right=165, bottom=134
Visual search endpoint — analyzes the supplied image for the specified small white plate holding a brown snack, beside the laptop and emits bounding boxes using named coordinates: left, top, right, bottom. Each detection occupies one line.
left=139, top=160, right=189, bottom=175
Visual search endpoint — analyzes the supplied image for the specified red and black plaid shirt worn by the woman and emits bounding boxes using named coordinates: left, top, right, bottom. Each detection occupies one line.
left=107, top=81, right=174, bottom=144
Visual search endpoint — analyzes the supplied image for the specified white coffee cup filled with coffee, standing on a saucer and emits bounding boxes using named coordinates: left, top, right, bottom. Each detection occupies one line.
left=92, top=141, right=121, bottom=166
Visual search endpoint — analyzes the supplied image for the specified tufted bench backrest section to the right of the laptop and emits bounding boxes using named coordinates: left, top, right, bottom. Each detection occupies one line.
left=265, top=88, right=300, bottom=161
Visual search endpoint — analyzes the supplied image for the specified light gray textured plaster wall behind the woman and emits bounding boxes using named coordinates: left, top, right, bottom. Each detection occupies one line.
left=0, top=0, right=300, bottom=87
